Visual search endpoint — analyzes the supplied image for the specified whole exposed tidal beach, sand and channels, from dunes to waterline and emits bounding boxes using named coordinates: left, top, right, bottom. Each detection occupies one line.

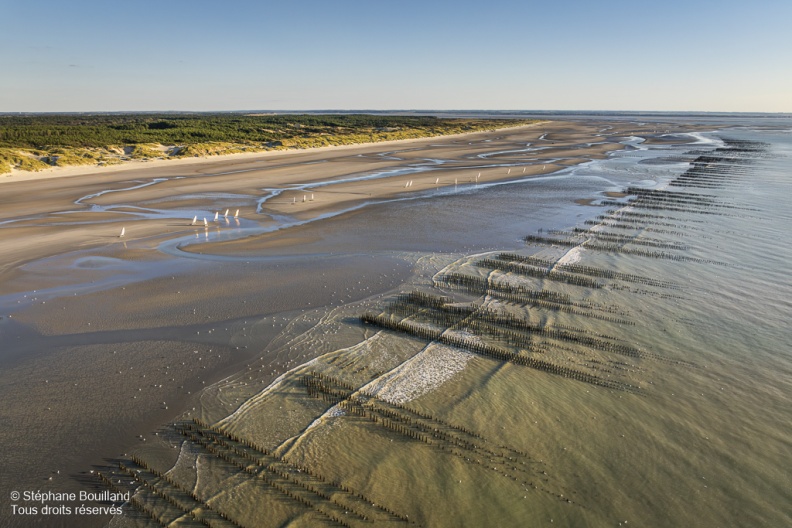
left=0, top=119, right=716, bottom=526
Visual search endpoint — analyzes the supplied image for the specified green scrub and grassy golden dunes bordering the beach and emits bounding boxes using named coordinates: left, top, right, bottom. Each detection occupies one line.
left=0, top=113, right=532, bottom=173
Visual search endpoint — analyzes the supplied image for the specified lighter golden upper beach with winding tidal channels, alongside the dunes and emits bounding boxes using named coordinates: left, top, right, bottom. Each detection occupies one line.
left=0, top=122, right=650, bottom=286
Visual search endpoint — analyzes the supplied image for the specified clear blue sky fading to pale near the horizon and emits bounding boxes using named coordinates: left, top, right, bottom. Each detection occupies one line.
left=0, top=0, right=792, bottom=112
